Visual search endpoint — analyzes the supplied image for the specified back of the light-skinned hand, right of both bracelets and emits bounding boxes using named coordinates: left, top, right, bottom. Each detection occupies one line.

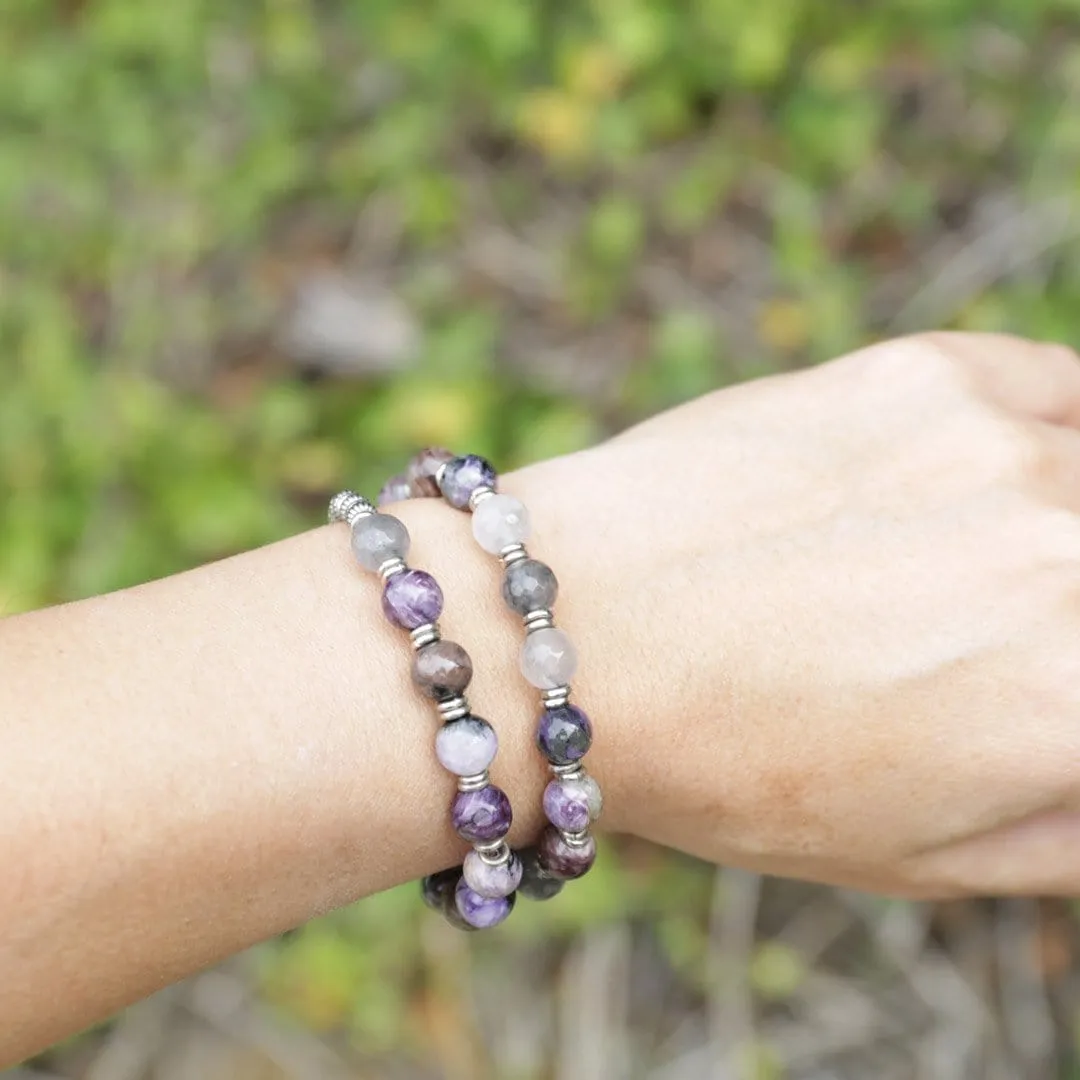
left=512, top=334, right=1080, bottom=895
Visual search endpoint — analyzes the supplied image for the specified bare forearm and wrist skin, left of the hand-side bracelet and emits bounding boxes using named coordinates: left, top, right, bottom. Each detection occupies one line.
left=0, top=462, right=626, bottom=1061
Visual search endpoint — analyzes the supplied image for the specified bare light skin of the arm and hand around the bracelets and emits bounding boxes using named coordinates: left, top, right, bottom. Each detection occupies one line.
left=0, top=335, right=1080, bottom=1064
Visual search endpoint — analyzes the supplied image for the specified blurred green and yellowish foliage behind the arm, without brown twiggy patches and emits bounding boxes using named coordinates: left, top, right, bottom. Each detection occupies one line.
left=6, top=0, right=1080, bottom=1062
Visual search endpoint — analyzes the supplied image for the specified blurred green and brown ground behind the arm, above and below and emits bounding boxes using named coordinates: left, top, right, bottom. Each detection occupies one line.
left=0, top=0, right=1080, bottom=1080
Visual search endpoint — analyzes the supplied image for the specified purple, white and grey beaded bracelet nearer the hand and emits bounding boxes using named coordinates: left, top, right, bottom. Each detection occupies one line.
left=379, top=448, right=603, bottom=900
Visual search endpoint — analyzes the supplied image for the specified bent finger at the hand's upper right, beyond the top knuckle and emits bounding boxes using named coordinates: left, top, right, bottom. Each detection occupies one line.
left=913, top=333, right=1080, bottom=429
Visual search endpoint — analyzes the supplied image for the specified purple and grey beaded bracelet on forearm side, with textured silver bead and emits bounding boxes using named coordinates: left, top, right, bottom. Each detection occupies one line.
left=328, top=491, right=523, bottom=930
